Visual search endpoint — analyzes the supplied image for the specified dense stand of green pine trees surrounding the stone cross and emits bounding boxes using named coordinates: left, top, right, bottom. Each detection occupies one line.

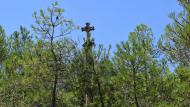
left=0, top=0, right=190, bottom=107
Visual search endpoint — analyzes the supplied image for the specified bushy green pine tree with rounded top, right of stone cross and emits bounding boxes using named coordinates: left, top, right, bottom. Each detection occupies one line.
left=114, top=25, right=165, bottom=107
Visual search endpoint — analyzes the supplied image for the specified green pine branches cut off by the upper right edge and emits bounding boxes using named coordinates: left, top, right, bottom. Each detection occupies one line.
left=159, top=0, right=190, bottom=65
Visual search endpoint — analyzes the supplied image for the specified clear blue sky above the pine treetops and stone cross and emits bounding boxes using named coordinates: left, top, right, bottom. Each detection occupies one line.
left=0, top=0, right=181, bottom=49
